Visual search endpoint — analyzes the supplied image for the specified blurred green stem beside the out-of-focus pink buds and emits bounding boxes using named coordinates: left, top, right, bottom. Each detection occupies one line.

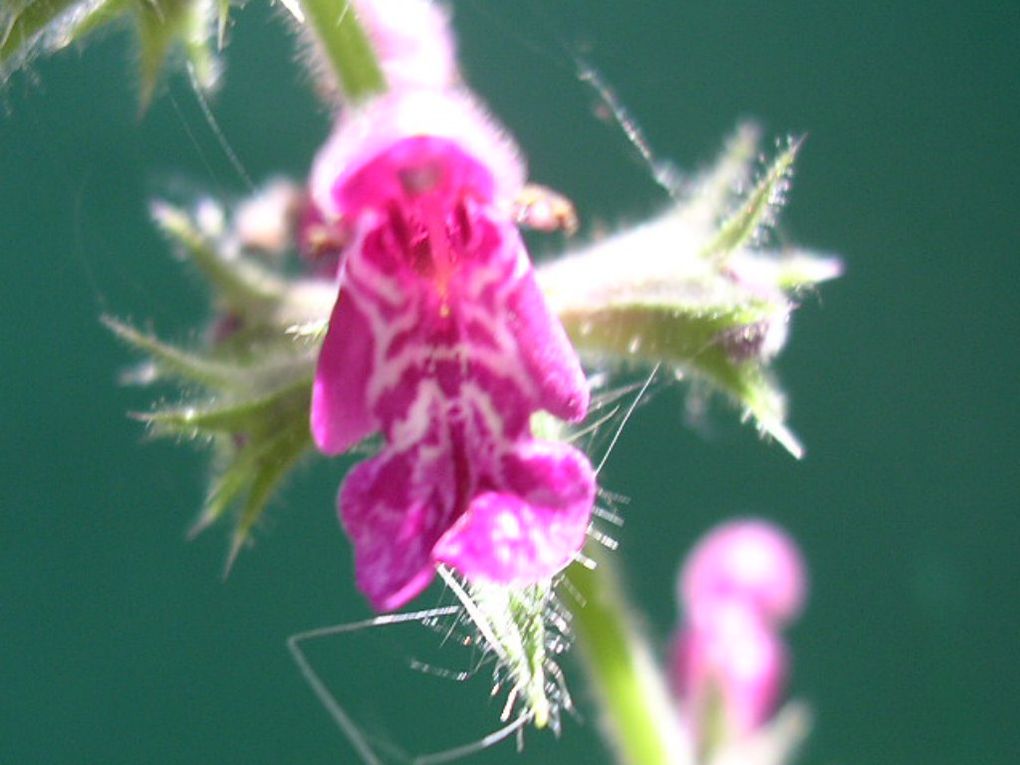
left=564, top=551, right=690, bottom=765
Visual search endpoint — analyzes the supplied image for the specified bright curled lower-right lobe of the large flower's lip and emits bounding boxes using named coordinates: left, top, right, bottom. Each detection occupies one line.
left=434, top=442, right=595, bottom=584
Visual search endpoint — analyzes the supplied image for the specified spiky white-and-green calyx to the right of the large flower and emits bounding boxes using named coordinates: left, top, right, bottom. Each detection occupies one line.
left=539, top=126, right=840, bottom=456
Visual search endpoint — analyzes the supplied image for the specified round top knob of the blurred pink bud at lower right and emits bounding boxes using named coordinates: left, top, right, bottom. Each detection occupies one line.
left=678, top=519, right=807, bottom=625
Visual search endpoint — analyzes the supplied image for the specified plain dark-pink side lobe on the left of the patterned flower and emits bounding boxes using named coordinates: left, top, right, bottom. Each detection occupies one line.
left=311, top=290, right=377, bottom=454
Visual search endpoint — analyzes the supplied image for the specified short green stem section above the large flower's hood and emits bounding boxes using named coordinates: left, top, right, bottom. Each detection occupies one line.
left=301, top=0, right=387, bottom=104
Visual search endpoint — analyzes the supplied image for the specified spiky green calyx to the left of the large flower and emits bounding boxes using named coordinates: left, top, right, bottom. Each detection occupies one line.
left=104, top=194, right=326, bottom=570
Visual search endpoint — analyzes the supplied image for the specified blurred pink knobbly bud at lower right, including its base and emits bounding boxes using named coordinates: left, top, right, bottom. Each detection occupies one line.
left=672, top=520, right=806, bottom=743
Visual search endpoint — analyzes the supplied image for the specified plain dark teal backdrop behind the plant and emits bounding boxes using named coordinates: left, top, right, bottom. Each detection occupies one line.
left=0, top=0, right=1020, bottom=765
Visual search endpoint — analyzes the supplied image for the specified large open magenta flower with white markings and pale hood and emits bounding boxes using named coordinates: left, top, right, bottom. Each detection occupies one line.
left=311, top=90, right=595, bottom=610
